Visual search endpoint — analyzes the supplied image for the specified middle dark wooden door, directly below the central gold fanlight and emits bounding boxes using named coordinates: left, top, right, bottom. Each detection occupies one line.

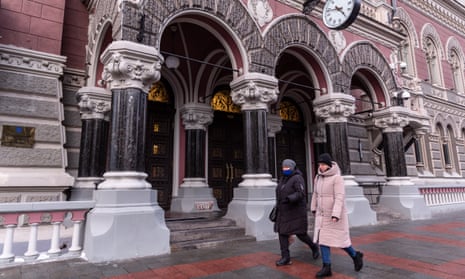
left=208, top=111, right=244, bottom=209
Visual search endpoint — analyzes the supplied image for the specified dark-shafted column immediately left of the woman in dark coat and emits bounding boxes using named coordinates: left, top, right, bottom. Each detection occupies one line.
left=226, top=73, right=278, bottom=240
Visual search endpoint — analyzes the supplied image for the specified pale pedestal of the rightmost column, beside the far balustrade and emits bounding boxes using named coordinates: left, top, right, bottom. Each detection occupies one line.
left=379, top=177, right=431, bottom=220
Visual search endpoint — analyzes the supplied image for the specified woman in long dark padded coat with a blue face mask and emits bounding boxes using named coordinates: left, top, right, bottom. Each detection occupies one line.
left=274, top=159, right=320, bottom=266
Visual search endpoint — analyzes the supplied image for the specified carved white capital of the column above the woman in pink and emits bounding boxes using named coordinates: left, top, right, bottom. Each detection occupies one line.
left=313, top=93, right=355, bottom=123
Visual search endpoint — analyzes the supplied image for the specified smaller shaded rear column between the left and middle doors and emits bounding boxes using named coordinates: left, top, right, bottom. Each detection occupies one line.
left=170, top=103, right=219, bottom=215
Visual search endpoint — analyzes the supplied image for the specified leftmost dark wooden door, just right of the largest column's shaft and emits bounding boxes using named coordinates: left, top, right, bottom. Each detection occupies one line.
left=145, top=101, right=174, bottom=210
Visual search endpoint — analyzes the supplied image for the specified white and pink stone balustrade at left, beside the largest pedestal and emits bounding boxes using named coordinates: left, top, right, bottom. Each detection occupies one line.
left=0, top=201, right=95, bottom=267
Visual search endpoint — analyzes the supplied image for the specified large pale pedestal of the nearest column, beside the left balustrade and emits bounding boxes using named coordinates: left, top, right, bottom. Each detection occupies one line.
left=84, top=189, right=170, bottom=262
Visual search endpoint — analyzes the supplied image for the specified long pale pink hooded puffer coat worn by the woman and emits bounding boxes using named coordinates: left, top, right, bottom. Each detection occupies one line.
left=311, top=162, right=351, bottom=248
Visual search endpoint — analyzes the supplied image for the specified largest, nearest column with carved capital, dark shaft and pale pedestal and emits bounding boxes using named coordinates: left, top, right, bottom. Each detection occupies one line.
left=84, top=41, right=170, bottom=262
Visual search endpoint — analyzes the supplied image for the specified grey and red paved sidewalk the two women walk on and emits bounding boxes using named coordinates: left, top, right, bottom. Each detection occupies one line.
left=0, top=212, right=465, bottom=279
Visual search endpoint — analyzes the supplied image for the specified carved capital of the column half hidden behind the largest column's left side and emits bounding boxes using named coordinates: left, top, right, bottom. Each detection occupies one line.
left=76, top=87, right=111, bottom=121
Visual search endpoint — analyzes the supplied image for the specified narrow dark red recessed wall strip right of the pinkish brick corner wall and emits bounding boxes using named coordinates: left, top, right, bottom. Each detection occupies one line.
left=61, top=0, right=89, bottom=70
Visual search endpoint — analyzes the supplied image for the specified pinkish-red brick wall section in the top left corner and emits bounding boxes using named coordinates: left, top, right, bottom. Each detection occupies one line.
left=0, top=0, right=65, bottom=54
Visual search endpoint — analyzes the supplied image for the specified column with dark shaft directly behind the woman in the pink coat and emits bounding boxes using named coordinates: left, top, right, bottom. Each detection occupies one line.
left=313, top=93, right=377, bottom=229
